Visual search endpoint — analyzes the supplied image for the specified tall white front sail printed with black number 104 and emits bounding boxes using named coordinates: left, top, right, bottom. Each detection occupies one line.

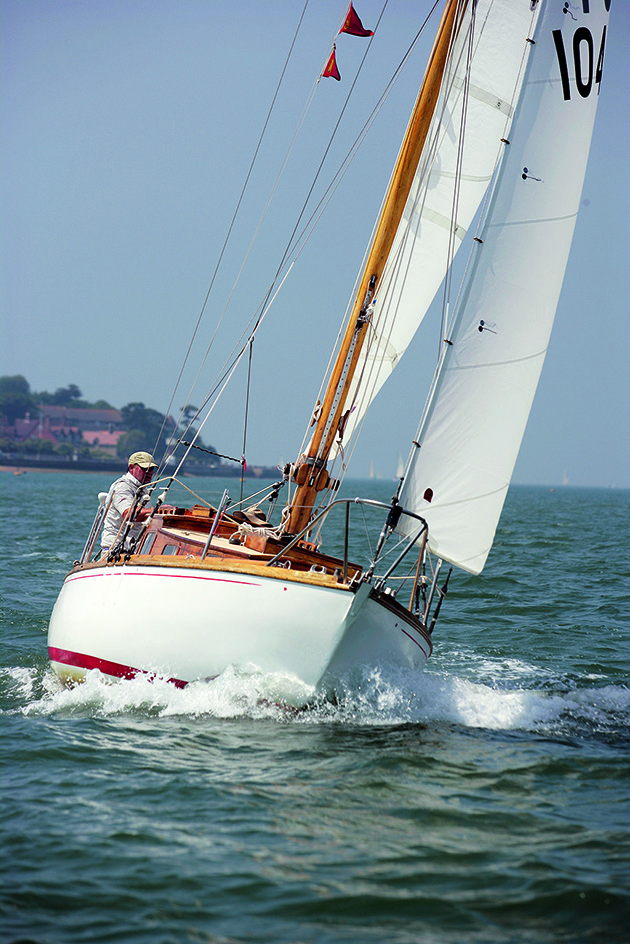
left=401, top=0, right=610, bottom=573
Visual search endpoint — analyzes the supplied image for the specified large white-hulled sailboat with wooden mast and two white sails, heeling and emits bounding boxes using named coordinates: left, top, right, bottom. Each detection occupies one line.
left=48, top=0, right=610, bottom=692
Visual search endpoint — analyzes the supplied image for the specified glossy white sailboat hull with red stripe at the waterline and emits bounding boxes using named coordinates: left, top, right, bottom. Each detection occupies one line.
left=48, top=563, right=431, bottom=687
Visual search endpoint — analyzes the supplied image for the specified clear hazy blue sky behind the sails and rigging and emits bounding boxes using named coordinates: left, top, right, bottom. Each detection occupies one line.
left=0, top=0, right=630, bottom=488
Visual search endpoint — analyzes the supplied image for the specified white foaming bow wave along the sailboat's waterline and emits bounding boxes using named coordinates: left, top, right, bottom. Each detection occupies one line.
left=10, top=660, right=630, bottom=732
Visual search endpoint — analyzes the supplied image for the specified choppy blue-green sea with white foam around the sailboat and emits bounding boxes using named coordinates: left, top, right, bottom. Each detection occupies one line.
left=0, top=471, right=630, bottom=944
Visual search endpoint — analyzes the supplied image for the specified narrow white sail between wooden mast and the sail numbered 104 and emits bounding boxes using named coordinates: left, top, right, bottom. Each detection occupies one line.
left=334, top=0, right=536, bottom=458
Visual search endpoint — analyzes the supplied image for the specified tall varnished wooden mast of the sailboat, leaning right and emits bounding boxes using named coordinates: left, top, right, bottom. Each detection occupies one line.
left=285, top=0, right=466, bottom=534
